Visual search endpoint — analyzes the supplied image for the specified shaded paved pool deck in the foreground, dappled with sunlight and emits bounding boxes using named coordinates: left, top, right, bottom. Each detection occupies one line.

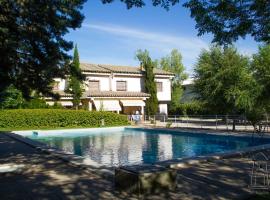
left=0, top=133, right=258, bottom=200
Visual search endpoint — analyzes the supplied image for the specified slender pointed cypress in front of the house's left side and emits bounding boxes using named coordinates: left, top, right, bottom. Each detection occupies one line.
left=67, top=45, right=84, bottom=110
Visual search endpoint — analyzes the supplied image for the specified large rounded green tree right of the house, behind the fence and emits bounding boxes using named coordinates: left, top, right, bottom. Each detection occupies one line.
left=195, top=47, right=260, bottom=114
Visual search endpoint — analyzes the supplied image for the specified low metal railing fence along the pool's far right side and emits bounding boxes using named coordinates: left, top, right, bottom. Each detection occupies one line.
left=142, top=115, right=270, bottom=132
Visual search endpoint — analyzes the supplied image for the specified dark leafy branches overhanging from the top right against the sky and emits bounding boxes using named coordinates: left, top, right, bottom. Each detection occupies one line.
left=102, top=0, right=270, bottom=44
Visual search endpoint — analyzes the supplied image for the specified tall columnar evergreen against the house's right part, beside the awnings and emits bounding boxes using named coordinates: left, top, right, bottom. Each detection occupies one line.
left=136, top=50, right=158, bottom=115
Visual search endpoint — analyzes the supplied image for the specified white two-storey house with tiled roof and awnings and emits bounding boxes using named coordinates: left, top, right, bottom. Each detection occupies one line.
left=46, top=63, right=174, bottom=114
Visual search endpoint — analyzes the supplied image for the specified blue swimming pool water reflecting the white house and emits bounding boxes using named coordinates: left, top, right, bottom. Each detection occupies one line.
left=29, top=128, right=270, bottom=166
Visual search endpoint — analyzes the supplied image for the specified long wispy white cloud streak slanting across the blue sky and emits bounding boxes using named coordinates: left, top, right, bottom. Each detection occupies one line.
left=83, top=23, right=208, bottom=67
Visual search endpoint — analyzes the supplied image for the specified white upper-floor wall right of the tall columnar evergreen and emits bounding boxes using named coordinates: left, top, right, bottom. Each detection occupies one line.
left=155, top=78, right=171, bottom=101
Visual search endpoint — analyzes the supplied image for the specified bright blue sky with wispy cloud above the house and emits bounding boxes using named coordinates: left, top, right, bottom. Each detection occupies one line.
left=66, top=0, right=258, bottom=74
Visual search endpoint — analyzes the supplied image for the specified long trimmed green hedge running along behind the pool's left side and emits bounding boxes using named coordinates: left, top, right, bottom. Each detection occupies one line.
left=0, top=109, right=128, bottom=130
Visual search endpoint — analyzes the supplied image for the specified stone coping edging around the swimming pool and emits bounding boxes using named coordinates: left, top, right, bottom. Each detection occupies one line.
left=4, top=126, right=270, bottom=179
